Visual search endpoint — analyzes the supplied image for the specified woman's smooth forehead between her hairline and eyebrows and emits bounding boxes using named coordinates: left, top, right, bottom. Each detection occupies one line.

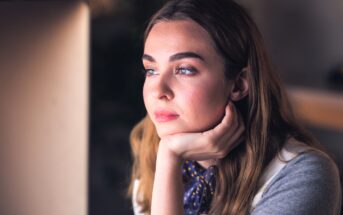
left=144, top=20, right=215, bottom=54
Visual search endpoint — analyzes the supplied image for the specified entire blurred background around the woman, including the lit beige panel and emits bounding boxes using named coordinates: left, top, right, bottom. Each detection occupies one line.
left=0, top=0, right=343, bottom=215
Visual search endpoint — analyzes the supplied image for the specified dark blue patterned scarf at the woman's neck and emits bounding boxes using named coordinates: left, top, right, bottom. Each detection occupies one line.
left=182, top=160, right=217, bottom=215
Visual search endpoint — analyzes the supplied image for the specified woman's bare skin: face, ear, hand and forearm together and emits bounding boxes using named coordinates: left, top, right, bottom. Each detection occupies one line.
left=142, top=20, right=248, bottom=215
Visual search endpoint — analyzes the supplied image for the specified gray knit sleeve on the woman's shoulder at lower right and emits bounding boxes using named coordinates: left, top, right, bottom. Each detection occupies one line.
left=251, top=152, right=341, bottom=215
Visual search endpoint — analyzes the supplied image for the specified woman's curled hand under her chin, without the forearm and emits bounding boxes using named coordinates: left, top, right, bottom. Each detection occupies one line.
left=160, top=101, right=245, bottom=161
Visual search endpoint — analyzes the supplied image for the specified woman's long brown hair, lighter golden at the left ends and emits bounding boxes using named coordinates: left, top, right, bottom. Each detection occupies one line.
left=129, top=0, right=328, bottom=215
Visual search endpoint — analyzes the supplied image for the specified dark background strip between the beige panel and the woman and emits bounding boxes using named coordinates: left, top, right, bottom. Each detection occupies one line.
left=89, top=0, right=168, bottom=215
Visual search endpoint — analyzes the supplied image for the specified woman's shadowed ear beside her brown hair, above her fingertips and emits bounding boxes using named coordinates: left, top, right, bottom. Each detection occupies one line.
left=230, top=66, right=249, bottom=101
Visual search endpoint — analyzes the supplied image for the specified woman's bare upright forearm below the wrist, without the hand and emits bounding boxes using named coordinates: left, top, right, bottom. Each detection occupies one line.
left=151, top=143, right=183, bottom=215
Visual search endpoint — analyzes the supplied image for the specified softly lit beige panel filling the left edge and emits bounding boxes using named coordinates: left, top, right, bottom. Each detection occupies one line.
left=0, top=1, right=89, bottom=215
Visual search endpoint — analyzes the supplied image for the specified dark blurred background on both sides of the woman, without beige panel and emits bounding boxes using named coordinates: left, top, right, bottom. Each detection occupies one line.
left=89, top=0, right=343, bottom=215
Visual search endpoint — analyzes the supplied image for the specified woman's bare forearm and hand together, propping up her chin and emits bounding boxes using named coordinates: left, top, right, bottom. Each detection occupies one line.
left=151, top=102, right=245, bottom=215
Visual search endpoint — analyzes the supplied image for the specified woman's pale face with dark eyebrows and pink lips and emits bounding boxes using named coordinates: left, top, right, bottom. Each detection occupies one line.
left=142, top=20, right=230, bottom=137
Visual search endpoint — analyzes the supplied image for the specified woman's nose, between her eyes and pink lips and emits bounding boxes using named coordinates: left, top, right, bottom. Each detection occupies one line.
left=149, top=74, right=174, bottom=100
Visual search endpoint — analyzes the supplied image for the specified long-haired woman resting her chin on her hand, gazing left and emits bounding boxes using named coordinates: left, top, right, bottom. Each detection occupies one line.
left=129, top=0, right=341, bottom=215
